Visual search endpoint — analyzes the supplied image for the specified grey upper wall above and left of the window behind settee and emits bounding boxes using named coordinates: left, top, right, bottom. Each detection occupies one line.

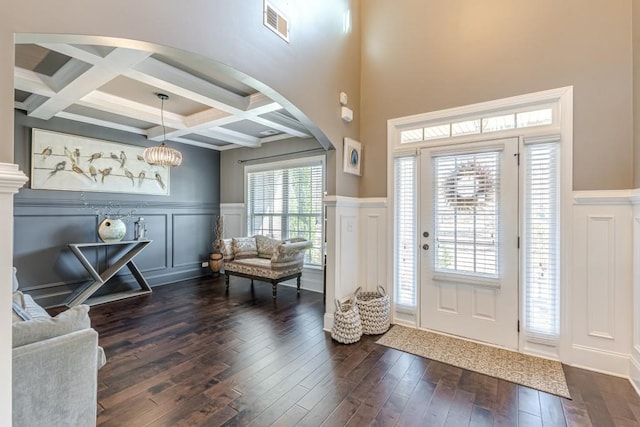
left=220, top=138, right=325, bottom=203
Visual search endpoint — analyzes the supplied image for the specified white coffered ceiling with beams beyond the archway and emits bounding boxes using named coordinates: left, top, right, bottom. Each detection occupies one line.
left=14, top=43, right=311, bottom=150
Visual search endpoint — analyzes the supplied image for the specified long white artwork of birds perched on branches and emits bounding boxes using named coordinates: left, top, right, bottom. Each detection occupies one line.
left=31, top=129, right=171, bottom=196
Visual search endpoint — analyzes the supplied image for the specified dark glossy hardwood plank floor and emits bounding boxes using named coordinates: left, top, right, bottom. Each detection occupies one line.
left=90, top=278, right=640, bottom=426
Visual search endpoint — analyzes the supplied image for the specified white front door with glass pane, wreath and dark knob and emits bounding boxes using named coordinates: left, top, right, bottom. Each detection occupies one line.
left=420, top=138, right=518, bottom=350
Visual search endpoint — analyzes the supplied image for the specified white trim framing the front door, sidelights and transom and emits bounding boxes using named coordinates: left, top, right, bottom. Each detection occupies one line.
left=387, top=86, right=573, bottom=361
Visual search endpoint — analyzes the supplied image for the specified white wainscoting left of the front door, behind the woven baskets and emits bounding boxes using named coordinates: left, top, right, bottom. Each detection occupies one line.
left=324, top=196, right=390, bottom=331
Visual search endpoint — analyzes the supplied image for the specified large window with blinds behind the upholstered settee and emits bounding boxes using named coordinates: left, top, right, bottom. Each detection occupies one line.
left=246, top=160, right=324, bottom=266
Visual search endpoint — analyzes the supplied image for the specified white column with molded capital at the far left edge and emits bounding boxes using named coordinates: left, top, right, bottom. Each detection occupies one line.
left=0, top=163, right=27, bottom=426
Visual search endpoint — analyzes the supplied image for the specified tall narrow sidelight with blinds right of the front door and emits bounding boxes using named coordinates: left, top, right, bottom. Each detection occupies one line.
left=524, top=142, right=560, bottom=340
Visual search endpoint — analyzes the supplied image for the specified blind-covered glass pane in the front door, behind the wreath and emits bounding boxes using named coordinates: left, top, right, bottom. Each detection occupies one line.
left=433, top=152, right=500, bottom=278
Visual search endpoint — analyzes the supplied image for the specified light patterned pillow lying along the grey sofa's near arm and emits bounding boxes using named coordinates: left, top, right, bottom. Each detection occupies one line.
left=13, top=305, right=91, bottom=347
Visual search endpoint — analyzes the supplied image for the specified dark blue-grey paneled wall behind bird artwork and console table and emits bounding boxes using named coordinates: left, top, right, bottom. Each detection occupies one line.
left=13, top=112, right=220, bottom=306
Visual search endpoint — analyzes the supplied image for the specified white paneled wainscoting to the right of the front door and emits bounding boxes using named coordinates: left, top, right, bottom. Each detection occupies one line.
left=567, top=191, right=634, bottom=377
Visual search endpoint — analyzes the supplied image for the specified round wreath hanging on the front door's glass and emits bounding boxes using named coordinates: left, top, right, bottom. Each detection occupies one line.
left=443, top=161, right=493, bottom=210
